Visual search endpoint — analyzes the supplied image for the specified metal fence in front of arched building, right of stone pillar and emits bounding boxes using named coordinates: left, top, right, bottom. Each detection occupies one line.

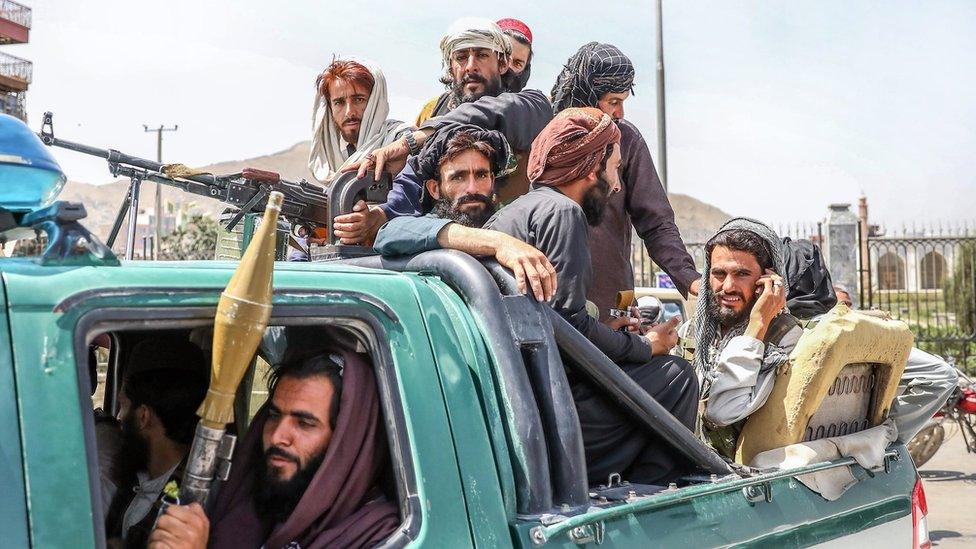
left=860, top=231, right=976, bottom=371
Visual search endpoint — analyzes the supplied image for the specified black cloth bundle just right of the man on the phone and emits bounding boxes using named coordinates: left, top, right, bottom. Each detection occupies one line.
left=783, top=236, right=837, bottom=320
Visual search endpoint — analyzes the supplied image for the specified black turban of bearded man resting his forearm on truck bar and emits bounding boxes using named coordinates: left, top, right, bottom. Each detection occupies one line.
left=408, top=123, right=518, bottom=213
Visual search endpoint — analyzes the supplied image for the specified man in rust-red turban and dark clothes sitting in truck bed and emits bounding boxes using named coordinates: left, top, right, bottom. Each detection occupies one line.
left=370, top=109, right=698, bottom=484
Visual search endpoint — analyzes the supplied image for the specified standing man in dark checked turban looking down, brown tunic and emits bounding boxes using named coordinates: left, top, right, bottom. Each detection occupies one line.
left=552, top=42, right=700, bottom=319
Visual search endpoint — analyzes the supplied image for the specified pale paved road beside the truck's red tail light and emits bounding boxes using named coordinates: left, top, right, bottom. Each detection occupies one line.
left=920, top=424, right=976, bottom=549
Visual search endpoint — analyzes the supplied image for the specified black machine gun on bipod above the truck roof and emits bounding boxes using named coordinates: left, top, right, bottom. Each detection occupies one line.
left=38, top=112, right=331, bottom=259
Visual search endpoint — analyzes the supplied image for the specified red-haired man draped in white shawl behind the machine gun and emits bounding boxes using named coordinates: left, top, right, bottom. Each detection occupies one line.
left=308, top=59, right=413, bottom=242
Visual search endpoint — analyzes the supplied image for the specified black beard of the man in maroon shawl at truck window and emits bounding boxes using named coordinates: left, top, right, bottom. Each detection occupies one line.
left=254, top=446, right=325, bottom=524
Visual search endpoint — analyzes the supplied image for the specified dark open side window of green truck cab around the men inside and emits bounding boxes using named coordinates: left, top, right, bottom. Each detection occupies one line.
left=79, top=320, right=419, bottom=546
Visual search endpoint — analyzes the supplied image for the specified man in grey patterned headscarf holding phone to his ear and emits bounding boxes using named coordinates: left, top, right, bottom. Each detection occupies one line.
left=695, top=217, right=803, bottom=457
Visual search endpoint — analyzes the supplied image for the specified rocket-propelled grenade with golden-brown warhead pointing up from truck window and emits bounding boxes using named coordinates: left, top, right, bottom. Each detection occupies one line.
left=180, top=191, right=284, bottom=504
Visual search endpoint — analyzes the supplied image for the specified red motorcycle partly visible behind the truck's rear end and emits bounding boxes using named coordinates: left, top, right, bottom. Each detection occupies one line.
left=908, top=368, right=976, bottom=467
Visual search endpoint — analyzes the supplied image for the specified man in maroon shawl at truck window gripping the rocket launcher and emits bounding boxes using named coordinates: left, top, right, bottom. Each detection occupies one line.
left=150, top=352, right=400, bottom=548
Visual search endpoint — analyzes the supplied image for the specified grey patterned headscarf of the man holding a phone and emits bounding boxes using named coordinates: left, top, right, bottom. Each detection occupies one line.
left=695, top=217, right=790, bottom=387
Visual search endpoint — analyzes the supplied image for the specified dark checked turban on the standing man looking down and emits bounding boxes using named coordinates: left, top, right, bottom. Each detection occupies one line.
left=552, top=42, right=634, bottom=113
